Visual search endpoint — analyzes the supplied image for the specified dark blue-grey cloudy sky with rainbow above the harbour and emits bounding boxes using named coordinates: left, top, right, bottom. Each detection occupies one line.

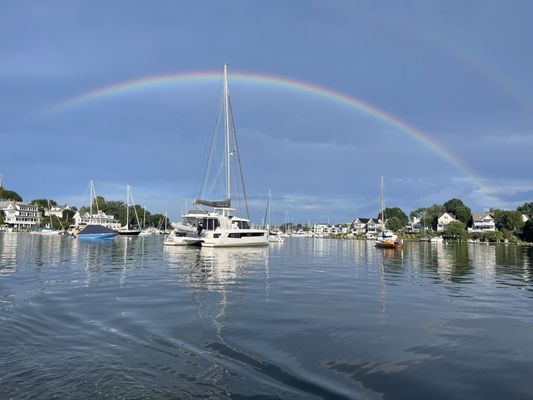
left=0, top=0, right=533, bottom=224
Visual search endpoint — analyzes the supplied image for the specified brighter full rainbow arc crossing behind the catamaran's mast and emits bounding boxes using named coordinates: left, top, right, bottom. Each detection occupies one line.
left=45, top=71, right=490, bottom=193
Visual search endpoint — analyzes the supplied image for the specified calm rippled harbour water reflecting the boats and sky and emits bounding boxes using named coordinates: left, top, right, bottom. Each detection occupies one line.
left=0, top=233, right=533, bottom=399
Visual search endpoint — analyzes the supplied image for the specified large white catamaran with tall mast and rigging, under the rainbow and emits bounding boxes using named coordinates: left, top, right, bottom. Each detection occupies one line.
left=183, top=64, right=268, bottom=247
